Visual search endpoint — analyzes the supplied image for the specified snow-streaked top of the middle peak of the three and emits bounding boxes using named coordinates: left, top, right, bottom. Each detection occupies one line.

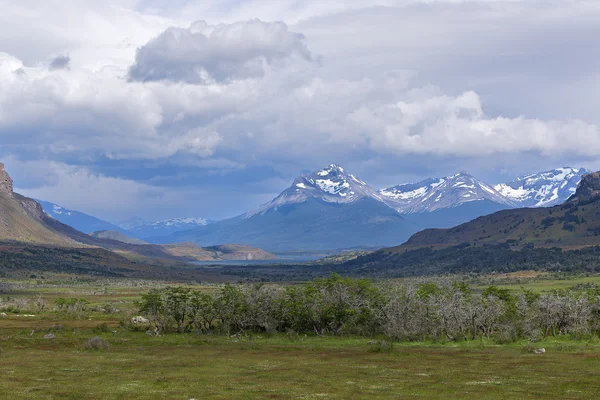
left=379, top=172, right=515, bottom=214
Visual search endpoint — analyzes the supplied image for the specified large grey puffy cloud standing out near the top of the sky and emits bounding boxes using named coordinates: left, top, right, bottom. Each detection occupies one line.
left=129, top=19, right=314, bottom=84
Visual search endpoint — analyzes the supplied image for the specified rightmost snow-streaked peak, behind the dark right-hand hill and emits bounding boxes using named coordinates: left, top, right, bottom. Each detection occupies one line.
left=495, top=167, right=591, bottom=207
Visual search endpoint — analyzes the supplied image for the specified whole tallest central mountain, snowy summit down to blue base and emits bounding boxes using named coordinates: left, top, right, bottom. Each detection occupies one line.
left=155, top=164, right=419, bottom=251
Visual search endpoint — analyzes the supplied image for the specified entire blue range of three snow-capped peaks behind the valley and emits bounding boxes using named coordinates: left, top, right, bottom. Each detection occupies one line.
left=147, top=164, right=587, bottom=252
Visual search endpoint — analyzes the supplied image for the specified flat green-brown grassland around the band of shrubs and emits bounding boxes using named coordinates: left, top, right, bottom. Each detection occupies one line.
left=0, top=276, right=600, bottom=399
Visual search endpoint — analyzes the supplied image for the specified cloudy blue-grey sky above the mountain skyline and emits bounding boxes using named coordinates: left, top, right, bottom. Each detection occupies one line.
left=0, top=0, right=600, bottom=221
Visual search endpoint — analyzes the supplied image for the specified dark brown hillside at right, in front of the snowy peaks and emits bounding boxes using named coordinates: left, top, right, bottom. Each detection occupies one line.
left=393, top=172, right=600, bottom=251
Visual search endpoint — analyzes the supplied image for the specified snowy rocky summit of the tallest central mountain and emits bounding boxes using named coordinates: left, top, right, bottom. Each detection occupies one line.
left=246, top=164, right=385, bottom=217
